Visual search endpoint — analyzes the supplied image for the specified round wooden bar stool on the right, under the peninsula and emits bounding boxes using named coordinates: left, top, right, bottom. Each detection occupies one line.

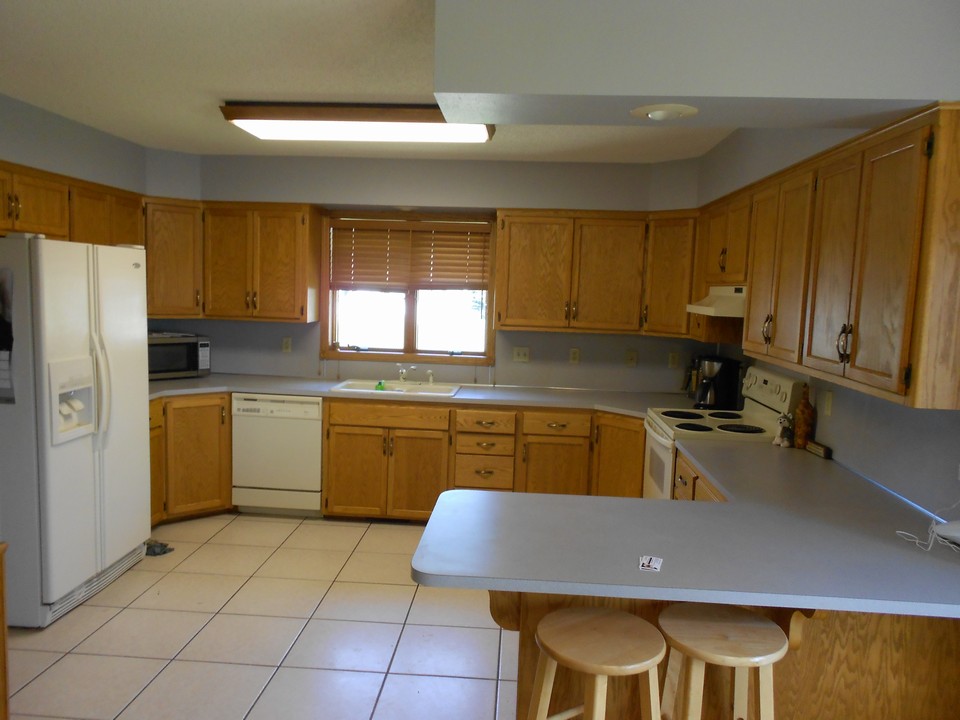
left=659, top=603, right=787, bottom=720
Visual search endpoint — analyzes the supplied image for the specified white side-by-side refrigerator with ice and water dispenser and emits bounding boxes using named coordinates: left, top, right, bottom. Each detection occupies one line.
left=0, top=235, right=150, bottom=627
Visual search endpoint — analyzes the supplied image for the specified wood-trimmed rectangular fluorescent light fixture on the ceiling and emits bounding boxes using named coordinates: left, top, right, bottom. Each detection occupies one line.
left=220, top=102, right=494, bottom=143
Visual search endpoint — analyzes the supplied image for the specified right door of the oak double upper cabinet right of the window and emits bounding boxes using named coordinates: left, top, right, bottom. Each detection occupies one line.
left=570, top=220, right=644, bottom=330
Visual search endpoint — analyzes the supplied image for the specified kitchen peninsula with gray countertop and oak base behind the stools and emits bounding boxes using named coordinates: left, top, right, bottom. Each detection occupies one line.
left=412, top=439, right=960, bottom=720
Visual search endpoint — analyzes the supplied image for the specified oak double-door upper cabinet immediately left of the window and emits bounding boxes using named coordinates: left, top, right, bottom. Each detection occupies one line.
left=203, top=203, right=323, bottom=322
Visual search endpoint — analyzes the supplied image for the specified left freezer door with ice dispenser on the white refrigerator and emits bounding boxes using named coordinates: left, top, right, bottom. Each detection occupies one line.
left=31, top=240, right=100, bottom=603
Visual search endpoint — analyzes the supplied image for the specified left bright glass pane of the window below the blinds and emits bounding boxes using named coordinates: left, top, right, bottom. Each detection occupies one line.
left=336, top=290, right=406, bottom=350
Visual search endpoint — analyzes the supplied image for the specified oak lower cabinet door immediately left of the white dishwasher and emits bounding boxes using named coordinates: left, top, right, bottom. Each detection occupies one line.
left=164, top=394, right=232, bottom=517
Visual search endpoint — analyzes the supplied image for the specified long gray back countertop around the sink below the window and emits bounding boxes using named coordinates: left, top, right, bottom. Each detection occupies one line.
left=150, top=373, right=692, bottom=417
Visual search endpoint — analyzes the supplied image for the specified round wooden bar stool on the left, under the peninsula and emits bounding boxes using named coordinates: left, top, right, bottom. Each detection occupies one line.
left=527, top=607, right=667, bottom=720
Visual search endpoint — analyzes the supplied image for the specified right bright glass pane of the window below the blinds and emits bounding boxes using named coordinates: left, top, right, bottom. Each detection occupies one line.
left=417, top=290, right=487, bottom=353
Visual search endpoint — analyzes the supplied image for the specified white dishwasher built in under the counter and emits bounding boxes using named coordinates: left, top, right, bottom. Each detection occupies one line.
left=233, top=393, right=323, bottom=515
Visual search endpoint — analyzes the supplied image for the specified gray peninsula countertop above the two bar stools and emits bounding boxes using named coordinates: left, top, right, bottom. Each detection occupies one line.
left=413, top=440, right=960, bottom=618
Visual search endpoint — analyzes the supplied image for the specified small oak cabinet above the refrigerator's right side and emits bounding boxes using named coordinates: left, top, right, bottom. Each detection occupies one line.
left=70, top=185, right=144, bottom=245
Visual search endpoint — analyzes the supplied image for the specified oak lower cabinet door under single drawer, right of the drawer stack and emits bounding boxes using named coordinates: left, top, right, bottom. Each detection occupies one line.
left=520, top=435, right=590, bottom=495
